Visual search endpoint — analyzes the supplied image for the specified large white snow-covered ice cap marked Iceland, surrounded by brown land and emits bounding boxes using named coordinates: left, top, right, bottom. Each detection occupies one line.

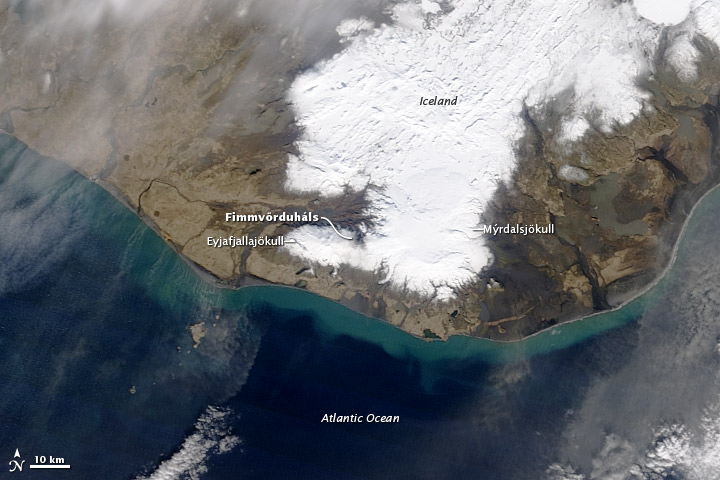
left=286, top=0, right=715, bottom=299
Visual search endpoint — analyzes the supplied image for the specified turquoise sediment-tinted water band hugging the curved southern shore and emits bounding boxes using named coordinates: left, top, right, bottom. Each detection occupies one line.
left=88, top=166, right=708, bottom=363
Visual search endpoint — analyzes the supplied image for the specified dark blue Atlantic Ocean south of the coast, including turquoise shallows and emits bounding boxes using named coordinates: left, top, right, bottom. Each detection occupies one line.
left=0, top=137, right=720, bottom=480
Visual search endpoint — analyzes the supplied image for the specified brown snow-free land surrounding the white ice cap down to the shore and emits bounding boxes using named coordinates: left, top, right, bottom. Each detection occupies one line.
left=0, top=2, right=720, bottom=342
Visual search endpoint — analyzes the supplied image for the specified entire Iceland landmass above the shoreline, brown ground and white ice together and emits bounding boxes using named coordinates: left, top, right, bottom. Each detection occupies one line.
left=0, top=0, right=720, bottom=341
